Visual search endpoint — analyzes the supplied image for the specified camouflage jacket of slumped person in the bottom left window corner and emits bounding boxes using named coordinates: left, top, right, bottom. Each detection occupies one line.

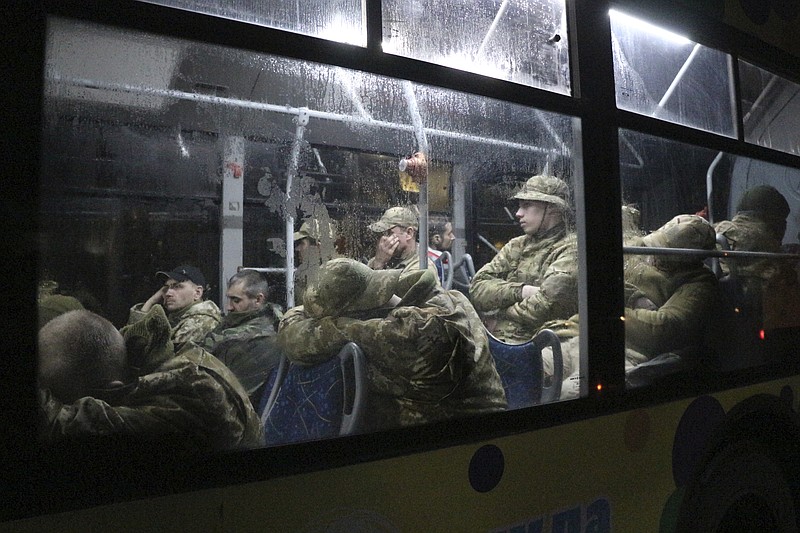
left=42, top=338, right=264, bottom=453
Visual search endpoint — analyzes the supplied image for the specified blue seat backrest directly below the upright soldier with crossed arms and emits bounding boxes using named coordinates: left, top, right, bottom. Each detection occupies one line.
left=487, top=329, right=564, bottom=409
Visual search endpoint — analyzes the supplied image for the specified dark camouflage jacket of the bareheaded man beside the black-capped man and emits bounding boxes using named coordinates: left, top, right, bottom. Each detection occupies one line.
left=199, top=304, right=281, bottom=408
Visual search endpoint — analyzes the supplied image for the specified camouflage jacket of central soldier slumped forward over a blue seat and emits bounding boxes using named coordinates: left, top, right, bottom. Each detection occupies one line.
left=278, top=272, right=506, bottom=430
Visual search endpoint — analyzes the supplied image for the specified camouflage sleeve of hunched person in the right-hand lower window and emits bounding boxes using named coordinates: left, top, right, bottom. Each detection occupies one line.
left=625, top=278, right=716, bottom=357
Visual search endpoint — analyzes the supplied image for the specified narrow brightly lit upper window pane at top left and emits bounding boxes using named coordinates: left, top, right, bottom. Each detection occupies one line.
left=137, top=0, right=367, bottom=46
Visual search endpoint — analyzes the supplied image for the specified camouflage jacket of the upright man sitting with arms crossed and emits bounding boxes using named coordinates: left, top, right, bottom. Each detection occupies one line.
left=469, top=226, right=578, bottom=343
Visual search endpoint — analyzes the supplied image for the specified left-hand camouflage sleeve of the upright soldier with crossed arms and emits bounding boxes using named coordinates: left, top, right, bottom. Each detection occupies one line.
left=469, top=239, right=523, bottom=313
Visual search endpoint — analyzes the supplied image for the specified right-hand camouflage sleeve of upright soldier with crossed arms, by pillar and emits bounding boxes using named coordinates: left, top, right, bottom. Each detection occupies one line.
left=504, top=244, right=578, bottom=328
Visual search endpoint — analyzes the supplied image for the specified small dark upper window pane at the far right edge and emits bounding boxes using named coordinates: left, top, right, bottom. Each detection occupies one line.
left=739, top=60, right=800, bottom=154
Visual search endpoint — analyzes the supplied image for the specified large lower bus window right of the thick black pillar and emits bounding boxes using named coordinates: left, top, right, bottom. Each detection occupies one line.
left=620, top=131, right=800, bottom=386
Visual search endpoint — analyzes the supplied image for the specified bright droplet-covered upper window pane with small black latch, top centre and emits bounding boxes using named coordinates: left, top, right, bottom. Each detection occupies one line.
left=383, top=0, right=570, bottom=94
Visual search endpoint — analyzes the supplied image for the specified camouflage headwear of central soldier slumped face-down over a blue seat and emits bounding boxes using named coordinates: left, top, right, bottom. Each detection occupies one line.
left=303, top=258, right=403, bottom=318
